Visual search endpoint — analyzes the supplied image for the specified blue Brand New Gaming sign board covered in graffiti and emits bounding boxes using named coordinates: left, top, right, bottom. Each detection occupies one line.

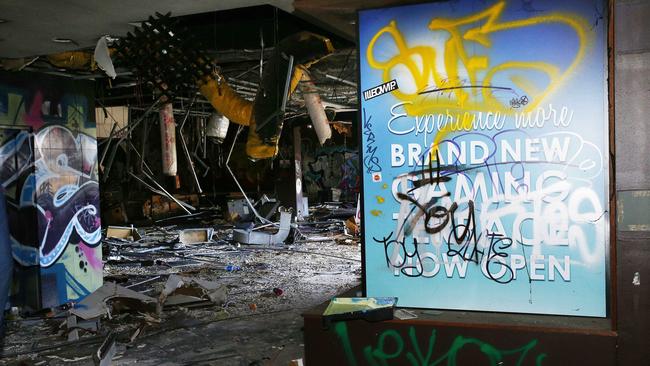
left=359, top=0, right=609, bottom=316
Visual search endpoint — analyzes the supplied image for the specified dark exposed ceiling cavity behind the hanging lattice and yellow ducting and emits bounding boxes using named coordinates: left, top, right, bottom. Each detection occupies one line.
left=0, top=4, right=357, bottom=116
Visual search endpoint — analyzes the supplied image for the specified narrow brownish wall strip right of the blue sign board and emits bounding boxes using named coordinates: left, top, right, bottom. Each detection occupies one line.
left=615, top=0, right=650, bottom=365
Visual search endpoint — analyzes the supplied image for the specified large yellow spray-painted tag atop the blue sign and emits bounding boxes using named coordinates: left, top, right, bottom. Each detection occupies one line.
left=366, top=1, right=591, bottom=152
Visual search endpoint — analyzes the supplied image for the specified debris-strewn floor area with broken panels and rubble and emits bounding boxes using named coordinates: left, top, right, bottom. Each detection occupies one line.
left=2, top=204, right=361, bottom=365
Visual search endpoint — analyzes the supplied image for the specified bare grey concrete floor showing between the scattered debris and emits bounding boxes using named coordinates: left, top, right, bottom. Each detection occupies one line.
left=0, top=226, right=361, bottom=365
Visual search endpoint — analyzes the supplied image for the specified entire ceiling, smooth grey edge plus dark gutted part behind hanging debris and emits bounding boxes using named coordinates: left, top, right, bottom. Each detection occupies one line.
left=0, top=0, right=428, bottom=116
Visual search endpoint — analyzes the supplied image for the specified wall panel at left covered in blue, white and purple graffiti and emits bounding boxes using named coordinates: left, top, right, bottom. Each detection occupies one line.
left=0, top=74, right=102, bottom=307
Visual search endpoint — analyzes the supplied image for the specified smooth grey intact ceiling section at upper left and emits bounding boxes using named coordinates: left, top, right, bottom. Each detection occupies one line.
left=0, top=0, right=293, bottom=58
